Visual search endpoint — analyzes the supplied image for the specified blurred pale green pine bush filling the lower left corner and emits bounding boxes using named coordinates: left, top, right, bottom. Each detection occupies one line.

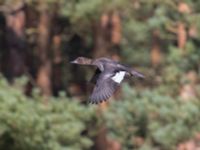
left=0, top=78, right=97, bottom=150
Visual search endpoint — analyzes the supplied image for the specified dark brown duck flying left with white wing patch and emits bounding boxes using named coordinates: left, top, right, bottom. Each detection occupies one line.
left=70, top=56, right=144, bottom=104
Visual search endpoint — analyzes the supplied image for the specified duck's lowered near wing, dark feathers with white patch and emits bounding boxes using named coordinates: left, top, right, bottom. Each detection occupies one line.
left=90, top=71, right=125, bottom=104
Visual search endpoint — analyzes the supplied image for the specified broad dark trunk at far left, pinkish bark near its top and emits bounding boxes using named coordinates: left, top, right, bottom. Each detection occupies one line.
left=4, top=3, right=27, bottom=81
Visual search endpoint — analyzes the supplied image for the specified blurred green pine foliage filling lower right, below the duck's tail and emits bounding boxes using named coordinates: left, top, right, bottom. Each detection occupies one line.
left=104, top=86, right=200, bottom=150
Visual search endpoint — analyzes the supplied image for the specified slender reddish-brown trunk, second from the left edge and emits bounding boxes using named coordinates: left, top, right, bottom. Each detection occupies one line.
left=37, top=1, right=51, bottom=98
